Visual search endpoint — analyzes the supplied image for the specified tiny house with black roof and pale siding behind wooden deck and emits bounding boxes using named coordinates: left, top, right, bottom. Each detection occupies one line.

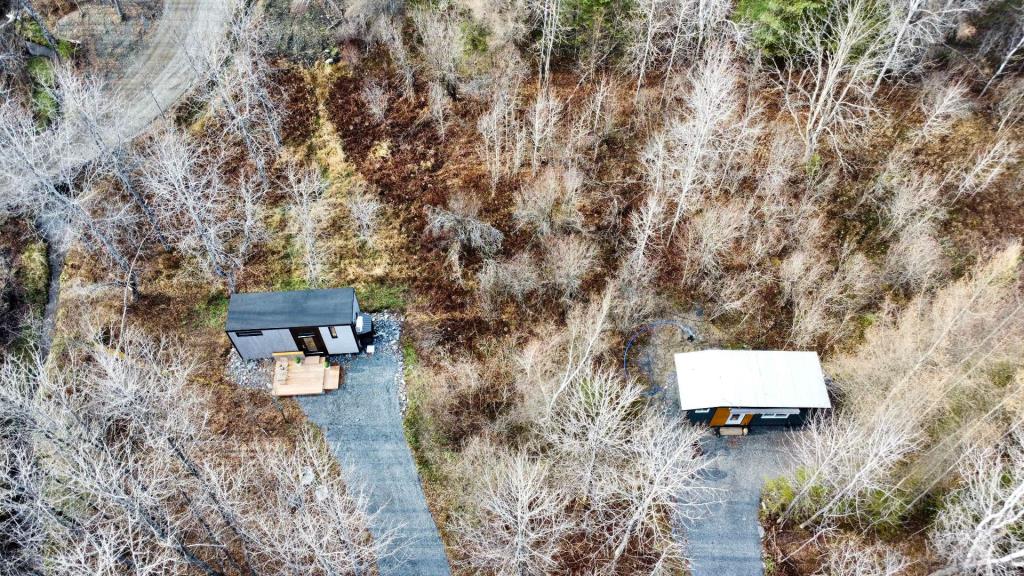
left=224, top=288, right=374, bottom=360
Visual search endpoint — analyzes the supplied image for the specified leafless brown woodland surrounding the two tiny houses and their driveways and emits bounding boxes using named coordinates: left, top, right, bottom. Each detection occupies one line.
left=0, top=0, right=1024, bottom=576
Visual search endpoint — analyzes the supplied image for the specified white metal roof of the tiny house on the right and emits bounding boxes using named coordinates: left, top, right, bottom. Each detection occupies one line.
left=676, top=349, right=831, bottom=410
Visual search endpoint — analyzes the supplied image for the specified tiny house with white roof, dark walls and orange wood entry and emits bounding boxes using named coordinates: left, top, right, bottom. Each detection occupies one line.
left=675, top=349, right=831, bottom=427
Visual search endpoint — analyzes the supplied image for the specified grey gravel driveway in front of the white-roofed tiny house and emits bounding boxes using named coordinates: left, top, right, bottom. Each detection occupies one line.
left=684, top=429, right=792, bottom=576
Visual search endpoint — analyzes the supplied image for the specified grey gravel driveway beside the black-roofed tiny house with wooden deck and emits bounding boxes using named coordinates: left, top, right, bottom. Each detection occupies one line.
left=299, top=315, right=450, bottom=576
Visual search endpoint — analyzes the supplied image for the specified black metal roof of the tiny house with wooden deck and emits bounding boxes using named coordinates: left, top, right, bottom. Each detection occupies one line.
left=226, top=288, right=355, bottom=332
